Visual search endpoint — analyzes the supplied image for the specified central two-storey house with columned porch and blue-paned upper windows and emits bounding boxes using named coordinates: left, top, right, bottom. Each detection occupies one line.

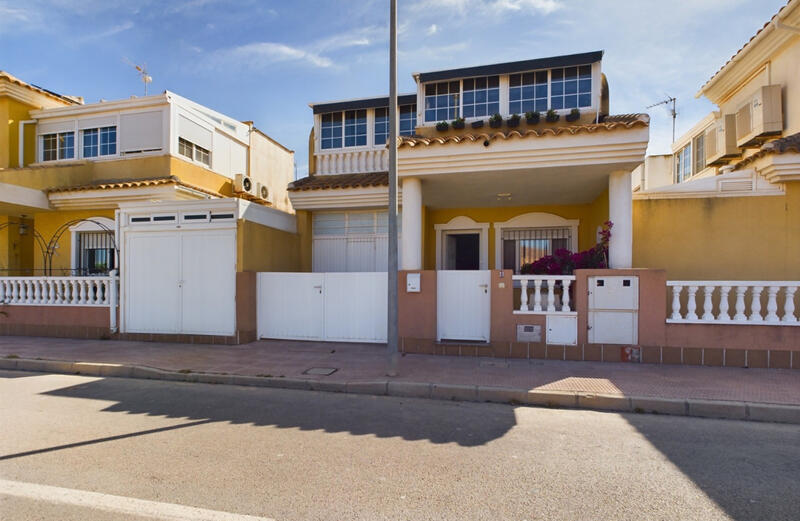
left=289, top=51, right=649, bottom=273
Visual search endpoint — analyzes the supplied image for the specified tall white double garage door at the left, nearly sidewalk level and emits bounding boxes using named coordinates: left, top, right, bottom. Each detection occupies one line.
left=124, top=230, right=236, bottom=336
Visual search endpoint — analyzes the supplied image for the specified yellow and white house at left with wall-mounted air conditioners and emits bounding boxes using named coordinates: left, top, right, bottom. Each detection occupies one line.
left=0, top=72, right=294, bottom=275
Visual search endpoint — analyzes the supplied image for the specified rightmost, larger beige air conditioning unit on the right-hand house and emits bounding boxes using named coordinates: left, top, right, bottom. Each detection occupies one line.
left=736, top=85, right=783, bottom=147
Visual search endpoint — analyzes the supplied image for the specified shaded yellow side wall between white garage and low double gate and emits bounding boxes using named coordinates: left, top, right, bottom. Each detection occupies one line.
left=236, top=220, right=301, bottom=271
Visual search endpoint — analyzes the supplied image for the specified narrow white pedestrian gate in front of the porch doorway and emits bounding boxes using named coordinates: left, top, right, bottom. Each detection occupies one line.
left=436, top=270, right=491, bottom=342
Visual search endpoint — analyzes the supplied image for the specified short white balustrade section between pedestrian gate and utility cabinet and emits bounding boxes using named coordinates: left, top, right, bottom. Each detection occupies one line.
left=512, top=275, right=577, bottom=315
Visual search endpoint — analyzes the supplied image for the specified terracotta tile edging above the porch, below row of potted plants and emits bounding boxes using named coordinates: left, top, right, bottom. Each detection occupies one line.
left=398, top=114, right=650, bottom=147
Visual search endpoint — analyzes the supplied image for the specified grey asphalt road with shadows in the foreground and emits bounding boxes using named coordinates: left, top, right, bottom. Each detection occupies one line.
left=0, top=372, right=800, bottom=521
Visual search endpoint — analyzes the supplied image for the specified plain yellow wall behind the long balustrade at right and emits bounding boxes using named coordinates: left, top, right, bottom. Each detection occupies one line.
left=633, top=182, right=800, bottom=280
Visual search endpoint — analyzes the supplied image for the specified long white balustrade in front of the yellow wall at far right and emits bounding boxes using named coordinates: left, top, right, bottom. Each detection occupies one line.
left=667, top=280, right=800, bottom=326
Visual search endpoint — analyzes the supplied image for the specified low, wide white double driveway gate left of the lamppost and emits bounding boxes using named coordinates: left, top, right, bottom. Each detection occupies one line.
left=257, top=272, right=388, bottom=342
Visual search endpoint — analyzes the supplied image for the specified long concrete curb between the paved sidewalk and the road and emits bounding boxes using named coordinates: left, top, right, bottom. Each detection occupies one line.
left=0, top=358, right=800, bottom=425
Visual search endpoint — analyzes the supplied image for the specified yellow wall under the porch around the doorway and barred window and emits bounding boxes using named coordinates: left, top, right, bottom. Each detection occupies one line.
left=422, top=191, right=608, bottom=270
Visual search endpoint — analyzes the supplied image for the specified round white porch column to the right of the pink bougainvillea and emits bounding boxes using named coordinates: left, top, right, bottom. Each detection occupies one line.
left=608, top=170, right=633, bottom=269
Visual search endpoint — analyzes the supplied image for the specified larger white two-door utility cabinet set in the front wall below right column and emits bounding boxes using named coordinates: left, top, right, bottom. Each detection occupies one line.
left=588, top=276, right=639, bottom=345
